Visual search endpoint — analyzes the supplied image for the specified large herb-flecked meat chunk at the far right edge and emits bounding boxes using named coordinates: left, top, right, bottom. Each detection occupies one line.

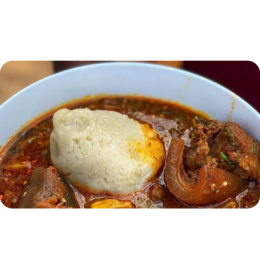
left=209, top=122, right=260, bottom=182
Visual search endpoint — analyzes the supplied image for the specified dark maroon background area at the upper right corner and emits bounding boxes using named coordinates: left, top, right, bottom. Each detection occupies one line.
left=183, top=60, right=260, bottom=112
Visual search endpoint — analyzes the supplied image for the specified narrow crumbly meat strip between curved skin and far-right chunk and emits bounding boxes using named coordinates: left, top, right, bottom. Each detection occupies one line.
left=184, top=120, right=223, bottom=170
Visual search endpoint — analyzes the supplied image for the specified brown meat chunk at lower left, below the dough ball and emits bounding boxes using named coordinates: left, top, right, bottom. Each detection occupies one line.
left=18, top=167, right=75, bottom=209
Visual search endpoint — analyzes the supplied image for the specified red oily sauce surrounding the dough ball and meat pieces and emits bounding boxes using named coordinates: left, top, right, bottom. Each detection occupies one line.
left=0, top=96, right=260, bottom=209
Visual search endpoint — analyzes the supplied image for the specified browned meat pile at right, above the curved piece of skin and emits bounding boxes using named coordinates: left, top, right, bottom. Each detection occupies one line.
left=184, top=121, right=260, bottom=182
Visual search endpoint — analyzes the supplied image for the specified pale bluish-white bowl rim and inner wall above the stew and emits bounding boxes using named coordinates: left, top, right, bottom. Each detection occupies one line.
left=0, top=63, right=260, bottom=150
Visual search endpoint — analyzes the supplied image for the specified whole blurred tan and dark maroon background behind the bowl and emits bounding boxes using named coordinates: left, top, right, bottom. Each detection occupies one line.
left=0, top=60, right=260, bottom=112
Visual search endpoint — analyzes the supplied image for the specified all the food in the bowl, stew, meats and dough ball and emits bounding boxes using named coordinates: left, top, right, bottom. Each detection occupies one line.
left=0, top=96, right=260, bottom=209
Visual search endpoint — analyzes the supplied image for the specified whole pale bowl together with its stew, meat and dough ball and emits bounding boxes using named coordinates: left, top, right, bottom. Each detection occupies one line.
left=0, top=63, right=260, bottom=209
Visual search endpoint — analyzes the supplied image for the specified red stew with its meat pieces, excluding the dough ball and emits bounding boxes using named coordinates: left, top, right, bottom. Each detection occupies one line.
left=0, top=96, right=260, bottom=209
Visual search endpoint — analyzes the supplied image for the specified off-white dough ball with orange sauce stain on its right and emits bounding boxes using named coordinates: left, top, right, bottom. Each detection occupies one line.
left=50, top=109, right=165, bottom=195
